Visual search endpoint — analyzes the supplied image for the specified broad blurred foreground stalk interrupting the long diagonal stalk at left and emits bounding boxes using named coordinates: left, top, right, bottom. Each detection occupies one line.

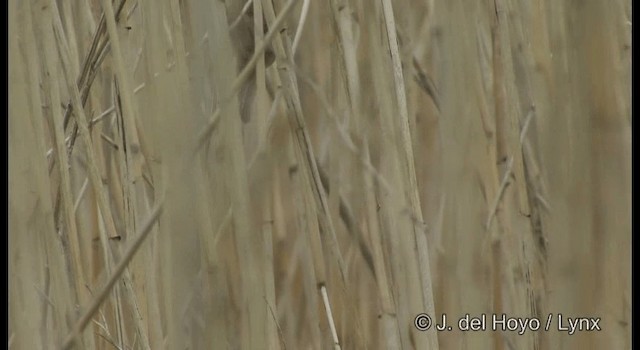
left=135, top=3, right=201, bottom=348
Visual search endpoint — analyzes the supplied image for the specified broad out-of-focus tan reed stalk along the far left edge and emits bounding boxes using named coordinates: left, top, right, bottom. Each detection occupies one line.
left=8, top=2, right=74, bottom=349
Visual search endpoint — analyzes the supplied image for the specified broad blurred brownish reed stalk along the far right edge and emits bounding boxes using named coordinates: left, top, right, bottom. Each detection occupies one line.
left=578, top=2, right=631, bottom=348
